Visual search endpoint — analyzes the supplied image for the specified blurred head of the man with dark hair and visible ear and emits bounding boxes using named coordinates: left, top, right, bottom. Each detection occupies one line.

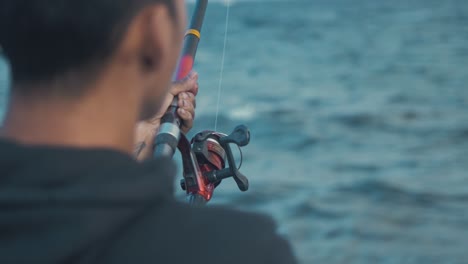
left=0, top=0, right=185, bottom=118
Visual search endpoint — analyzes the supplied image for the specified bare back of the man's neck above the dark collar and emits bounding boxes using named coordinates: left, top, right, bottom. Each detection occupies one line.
left=1, top=80, right=138, bottom=154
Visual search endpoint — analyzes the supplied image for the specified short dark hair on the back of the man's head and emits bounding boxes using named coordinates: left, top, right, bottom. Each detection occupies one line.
left=0, top=0, right=175, bottom=94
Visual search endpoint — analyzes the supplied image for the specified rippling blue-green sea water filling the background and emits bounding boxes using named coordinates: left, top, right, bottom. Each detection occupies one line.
left=0, top=0, right=468, bottom=264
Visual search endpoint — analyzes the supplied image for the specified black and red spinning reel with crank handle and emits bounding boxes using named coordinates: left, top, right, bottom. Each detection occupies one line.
left=178, top=125, right=250, bottom=203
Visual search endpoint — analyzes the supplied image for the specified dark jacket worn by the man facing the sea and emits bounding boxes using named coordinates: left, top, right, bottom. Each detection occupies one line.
left=0, top=141, right=295, bottom=264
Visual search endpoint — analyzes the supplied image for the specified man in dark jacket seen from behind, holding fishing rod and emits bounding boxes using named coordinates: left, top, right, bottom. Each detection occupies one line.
left=0, top=0, right=295, bottom=264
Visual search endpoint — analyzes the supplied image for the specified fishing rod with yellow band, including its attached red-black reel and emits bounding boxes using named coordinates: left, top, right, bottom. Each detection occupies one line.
left=153, top=0, right=250, bottom=205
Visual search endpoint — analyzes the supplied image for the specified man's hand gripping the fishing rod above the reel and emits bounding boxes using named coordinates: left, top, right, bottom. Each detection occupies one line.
left=134, top=72, right=198, bottom=161
